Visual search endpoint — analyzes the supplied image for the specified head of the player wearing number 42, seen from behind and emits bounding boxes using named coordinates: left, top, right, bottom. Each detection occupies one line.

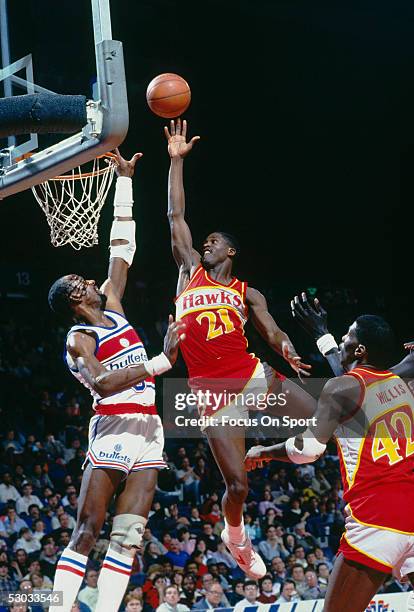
left=339, top=315, right=395, bottom=369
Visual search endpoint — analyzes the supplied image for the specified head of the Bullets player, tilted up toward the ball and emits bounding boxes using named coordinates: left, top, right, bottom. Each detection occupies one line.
left=48, top=274, right=106, bottom=322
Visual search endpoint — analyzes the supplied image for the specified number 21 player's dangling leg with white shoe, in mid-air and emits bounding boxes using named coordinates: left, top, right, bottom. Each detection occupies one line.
left=206, top=426, right=266, bottom=579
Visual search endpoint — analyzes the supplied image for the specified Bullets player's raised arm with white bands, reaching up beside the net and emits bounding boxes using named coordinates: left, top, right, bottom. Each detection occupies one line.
left=101, top=149, right=142, bottom=312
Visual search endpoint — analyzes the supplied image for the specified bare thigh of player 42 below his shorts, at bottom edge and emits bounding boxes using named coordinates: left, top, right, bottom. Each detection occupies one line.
left=323, top=553, right=388, bottom=612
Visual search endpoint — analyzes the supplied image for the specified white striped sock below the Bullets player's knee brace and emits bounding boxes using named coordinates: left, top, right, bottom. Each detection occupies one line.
left=95, top=545, right=135, bottom=612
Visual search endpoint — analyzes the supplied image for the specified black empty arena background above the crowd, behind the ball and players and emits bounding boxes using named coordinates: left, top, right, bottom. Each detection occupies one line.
left=0, top=0, right=414, bottom=360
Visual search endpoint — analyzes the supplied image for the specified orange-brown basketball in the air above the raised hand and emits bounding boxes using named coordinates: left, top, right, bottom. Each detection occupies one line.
left=147, top=72, right=191, bottom=119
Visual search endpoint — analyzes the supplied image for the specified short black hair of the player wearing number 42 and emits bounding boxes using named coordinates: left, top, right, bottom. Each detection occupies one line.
left=355, top=315, right=395, bottom=369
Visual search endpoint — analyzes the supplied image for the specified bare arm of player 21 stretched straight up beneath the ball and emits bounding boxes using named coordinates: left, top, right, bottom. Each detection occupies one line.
left=164, top=119, right=200, bottom=292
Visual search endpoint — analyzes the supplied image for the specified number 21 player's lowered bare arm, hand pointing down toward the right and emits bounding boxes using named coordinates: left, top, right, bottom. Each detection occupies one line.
left=246, top=287, right=311, bottom=376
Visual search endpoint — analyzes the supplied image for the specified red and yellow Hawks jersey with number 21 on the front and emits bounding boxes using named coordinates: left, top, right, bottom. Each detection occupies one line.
left=175, top=265, right=259, bottom=380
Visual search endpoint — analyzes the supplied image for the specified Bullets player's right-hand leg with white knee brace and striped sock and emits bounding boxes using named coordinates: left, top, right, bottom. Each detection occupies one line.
left=95, top=469, right=158, bottom=612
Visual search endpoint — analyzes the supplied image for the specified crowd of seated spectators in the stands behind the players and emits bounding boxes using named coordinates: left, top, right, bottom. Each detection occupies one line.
left=0, top=290, right=408, bottom=612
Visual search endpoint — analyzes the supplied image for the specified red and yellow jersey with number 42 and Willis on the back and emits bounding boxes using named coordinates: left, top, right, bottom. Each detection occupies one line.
left=335, top=366, right=414, bottom=534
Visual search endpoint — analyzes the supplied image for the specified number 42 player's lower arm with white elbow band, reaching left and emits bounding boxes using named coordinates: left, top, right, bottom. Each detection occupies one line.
left=245, top=376, right=360, bottom=471
